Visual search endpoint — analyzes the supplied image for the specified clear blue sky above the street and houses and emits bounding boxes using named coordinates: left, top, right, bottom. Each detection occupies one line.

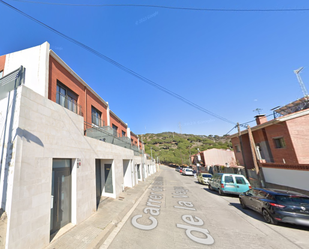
left=0, top=0, right=309, bottom=135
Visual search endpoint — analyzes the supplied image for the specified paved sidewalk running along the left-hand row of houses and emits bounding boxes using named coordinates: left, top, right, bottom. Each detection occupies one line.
left=45, top=172, right=158, bottom=249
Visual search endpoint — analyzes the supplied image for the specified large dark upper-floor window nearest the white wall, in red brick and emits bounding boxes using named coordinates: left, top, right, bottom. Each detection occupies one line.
left=56, top=81, right=77, bottom=113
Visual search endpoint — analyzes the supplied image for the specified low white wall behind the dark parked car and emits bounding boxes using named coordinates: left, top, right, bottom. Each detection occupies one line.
left=263, top=167, right=309, bottom=191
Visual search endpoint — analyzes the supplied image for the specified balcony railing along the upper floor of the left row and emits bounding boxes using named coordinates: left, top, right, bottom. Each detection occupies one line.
left=84, top=122, right=141, bottom=153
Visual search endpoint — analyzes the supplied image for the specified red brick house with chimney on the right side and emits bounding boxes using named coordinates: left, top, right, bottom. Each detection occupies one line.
left=231, top=98, right=309, bottom=169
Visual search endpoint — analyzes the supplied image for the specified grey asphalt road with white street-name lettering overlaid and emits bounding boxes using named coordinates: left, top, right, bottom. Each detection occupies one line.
left=100, top=166, right=309, bottom=249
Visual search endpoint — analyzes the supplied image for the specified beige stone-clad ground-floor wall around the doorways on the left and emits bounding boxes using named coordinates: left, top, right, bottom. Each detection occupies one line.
left=0, top=86, right=134, bottom=249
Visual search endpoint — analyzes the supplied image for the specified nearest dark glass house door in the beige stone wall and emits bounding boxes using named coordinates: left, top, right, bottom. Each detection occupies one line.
left=50, top=159, right=71, bottom=234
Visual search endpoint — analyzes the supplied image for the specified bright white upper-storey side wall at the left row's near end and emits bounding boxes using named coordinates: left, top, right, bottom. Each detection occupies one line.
left=3, top=42, right=49, bottom=97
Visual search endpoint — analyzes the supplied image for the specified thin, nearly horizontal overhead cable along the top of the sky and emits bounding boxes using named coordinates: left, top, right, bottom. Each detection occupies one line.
left=6, top=0, right=309, bottom=12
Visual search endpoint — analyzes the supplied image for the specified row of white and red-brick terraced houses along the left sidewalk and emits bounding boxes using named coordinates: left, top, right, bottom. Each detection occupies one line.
left=0, top=42, right=156, bottom=249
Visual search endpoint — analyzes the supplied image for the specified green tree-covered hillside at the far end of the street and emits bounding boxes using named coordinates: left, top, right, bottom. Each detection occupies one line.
left=139, top=132, right=232, bottom=165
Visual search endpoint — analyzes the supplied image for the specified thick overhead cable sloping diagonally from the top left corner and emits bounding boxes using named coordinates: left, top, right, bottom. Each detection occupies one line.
left=0, top=0, right=235, bottom=124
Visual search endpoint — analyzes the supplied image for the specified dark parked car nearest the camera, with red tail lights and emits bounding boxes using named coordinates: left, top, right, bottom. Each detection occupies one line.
left=239, top=188, right=309, bottom=226
